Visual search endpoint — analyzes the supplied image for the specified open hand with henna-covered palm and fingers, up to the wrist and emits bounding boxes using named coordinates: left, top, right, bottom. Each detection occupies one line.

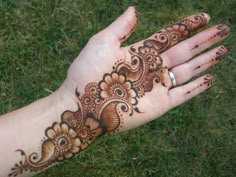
left=61, top=7, right=229, bottom=135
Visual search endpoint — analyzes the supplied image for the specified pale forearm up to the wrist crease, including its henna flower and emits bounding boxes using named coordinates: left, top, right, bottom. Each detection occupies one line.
left=0, top=81, right=88, bottom=176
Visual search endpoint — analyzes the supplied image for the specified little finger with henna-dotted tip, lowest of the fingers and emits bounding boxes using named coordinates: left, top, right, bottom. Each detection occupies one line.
left=169, top=74, right=215, bottom=108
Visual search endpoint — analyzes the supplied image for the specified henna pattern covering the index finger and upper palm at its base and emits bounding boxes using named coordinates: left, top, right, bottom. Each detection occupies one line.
left=113, top=13, right=207, bottom=98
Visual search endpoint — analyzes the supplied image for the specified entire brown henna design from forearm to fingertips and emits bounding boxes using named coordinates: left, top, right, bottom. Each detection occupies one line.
left=9, top=13, right=227, bottom=176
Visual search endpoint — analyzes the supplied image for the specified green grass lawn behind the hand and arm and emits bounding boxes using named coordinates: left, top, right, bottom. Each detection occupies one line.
left=0, top=0, right=236, bottom=177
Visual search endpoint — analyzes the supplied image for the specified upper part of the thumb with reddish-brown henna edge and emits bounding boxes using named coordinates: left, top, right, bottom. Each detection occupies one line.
left=105, top=6, right=138, bottom=43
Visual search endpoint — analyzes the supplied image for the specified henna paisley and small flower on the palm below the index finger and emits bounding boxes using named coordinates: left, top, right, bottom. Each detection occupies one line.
left=113, top=42, right=167, bottom=98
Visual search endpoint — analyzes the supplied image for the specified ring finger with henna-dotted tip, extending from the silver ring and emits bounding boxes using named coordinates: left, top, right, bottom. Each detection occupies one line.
left=171, top=46, right=227, bottom=85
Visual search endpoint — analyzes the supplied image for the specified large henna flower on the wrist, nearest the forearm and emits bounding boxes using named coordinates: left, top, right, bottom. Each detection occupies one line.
left=46, top=123, right=81, bottom=161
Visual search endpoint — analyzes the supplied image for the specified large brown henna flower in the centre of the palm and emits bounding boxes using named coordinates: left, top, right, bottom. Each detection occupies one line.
left=99, top=72, right=137, bottom=105
